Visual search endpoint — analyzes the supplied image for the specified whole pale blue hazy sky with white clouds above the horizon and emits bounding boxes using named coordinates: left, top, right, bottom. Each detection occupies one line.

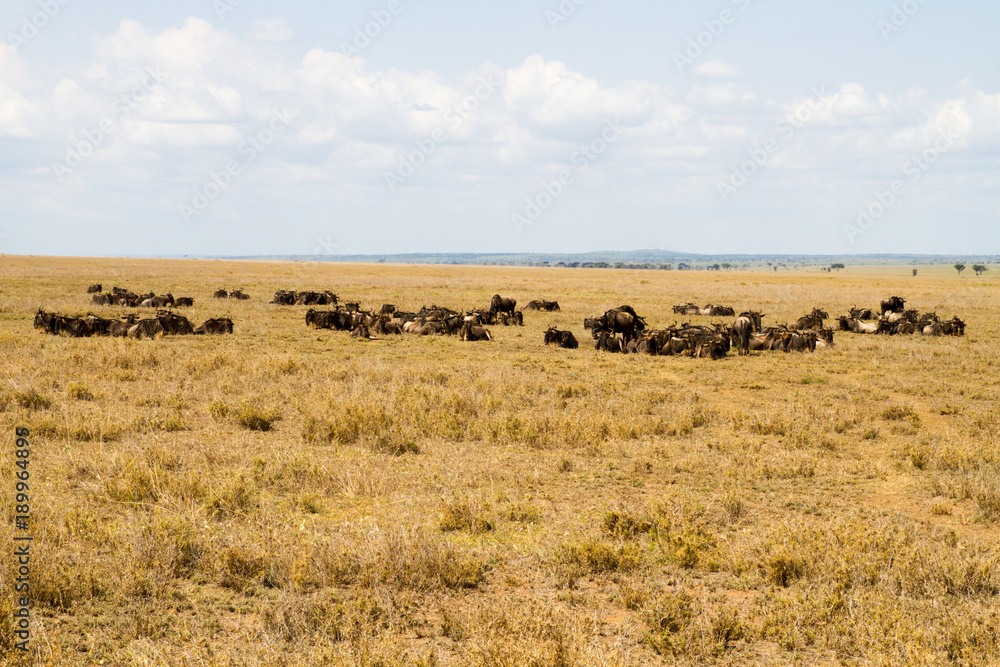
left=0, top=0, right=1000, bottom=255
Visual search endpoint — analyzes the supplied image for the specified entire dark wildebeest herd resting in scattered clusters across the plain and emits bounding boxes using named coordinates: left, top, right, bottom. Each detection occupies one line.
left=43, top=284, right=965, bottom=359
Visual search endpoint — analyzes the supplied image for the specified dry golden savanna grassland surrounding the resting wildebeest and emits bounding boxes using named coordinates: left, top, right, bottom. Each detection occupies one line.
left=0, top=257, right=1000, bottom=666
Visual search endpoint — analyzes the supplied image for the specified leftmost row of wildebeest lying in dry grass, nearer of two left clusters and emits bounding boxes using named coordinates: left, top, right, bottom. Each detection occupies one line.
left=35, top=308, right=233, bottom=338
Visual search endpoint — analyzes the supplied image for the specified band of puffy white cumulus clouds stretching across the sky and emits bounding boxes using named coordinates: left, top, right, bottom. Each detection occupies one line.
left=0, top=18, right=1000, bottom=256
